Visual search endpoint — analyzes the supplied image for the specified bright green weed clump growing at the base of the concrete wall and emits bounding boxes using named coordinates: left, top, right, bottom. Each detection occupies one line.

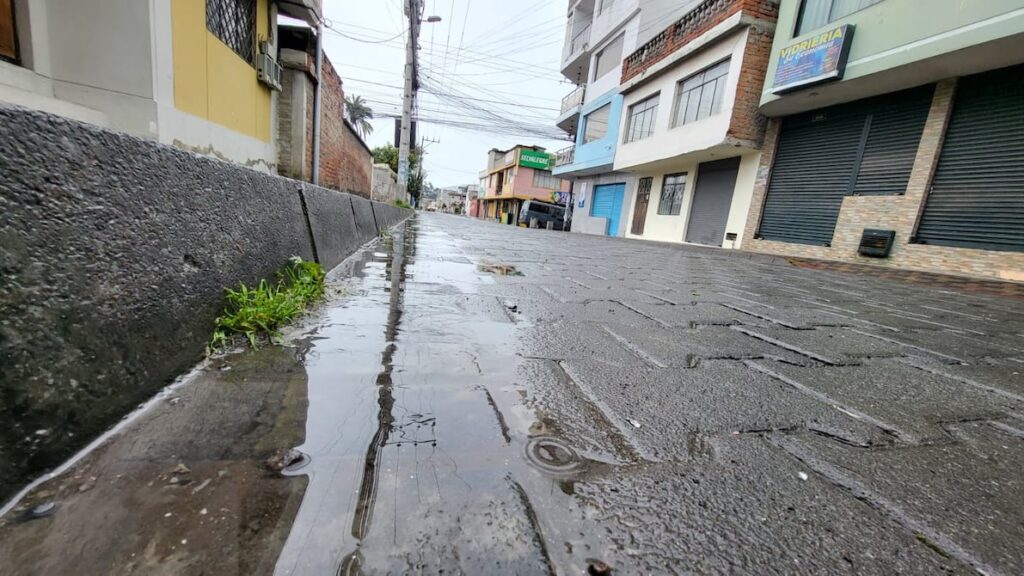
left=210, top=256, right=326, bottom=349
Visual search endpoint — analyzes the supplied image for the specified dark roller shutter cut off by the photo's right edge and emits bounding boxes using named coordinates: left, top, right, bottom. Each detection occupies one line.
left=914, top=66, right=1024, bottom=252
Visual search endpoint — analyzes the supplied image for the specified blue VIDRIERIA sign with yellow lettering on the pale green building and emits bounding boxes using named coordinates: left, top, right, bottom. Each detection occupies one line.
left=772, top=25, right=853, bottom=94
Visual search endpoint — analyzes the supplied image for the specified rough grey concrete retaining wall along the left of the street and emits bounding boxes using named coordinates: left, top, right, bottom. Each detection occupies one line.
left=0, top=108, right=412, bottom=499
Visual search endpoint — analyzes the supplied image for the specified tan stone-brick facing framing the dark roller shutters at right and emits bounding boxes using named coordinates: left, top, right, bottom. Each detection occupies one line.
left=743, top=80, right=1024, bottom=281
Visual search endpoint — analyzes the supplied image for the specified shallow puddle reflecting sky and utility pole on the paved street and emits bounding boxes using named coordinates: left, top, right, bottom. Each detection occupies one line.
left=275, top=217, right=598, bottom=575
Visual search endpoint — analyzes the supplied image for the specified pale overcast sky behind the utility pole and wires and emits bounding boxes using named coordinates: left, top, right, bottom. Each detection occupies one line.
left=324, top=0, right=573, bottom=187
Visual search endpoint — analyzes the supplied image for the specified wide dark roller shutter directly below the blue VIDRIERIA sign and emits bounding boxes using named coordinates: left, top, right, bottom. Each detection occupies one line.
left=758, top=85, right=935, bottom=246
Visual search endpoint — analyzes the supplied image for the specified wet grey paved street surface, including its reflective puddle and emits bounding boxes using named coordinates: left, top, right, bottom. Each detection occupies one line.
left=0, top=214, right=1024, bottom=575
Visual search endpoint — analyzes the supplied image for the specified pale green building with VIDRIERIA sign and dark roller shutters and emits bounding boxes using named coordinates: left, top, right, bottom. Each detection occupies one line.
left=743, top=0, right=1024, bottom=281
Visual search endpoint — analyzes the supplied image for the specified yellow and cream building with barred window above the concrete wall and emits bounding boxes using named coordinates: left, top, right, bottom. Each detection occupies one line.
left=0, top=0, right=319, bottom=171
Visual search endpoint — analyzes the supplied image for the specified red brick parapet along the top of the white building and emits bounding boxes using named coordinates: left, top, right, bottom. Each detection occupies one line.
left=621, top=0, right=778, bottom=84
